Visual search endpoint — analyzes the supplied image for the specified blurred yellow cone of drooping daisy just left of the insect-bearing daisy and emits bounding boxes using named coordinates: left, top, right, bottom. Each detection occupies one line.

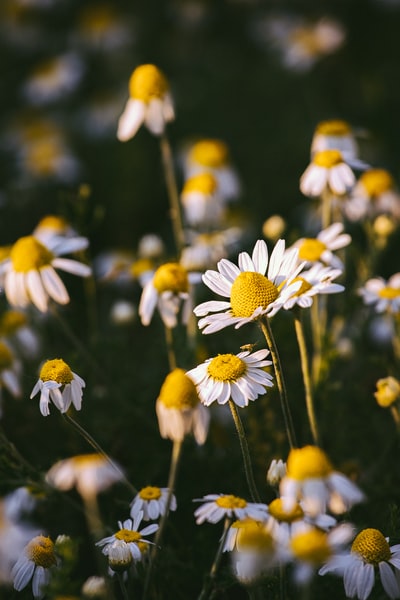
left=158, top=369, right=200, bottom=410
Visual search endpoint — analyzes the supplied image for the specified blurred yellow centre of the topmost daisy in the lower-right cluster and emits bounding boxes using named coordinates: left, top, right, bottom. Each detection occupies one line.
left=287, top=446, right=333, bottom=481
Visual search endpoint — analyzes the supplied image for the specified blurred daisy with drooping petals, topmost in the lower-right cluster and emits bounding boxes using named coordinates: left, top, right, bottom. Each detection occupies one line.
left=280, top=446, right=364, bottom=516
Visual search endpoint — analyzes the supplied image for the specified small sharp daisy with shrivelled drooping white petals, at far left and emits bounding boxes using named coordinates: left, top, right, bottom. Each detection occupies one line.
left=30, top=358, right=86, bottom=417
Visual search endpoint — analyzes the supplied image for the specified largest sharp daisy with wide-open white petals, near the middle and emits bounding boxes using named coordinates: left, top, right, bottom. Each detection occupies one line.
left=194, top=240, right=303, bottom=334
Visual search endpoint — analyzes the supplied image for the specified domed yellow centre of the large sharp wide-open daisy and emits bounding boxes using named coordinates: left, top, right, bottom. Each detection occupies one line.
left=231, top=271, right=279, bottom=317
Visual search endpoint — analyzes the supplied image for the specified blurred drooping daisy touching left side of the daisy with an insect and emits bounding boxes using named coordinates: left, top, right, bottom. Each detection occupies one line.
left=156, top=369, right=210, bottom=444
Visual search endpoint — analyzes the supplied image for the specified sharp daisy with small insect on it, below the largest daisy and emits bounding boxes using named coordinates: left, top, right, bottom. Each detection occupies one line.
left=186, top=350, right=273, bottom=407
